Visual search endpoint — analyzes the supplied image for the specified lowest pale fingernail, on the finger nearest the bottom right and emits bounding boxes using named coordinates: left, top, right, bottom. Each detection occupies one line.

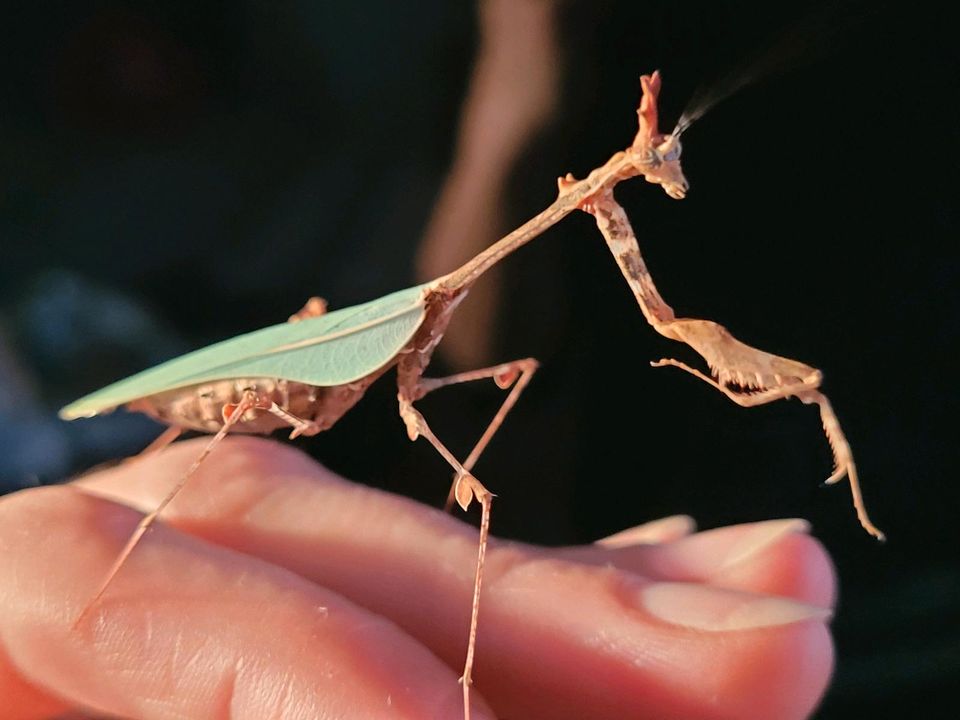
left=639, top=582, right=832, bottom=632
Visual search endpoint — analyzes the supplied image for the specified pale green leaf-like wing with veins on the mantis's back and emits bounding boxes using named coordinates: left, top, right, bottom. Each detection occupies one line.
left=60, top=285, right=427, bottom=420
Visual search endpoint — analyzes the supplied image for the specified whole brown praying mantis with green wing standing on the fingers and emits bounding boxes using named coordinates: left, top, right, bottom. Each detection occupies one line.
left=60, top=72, right=883, bottom=720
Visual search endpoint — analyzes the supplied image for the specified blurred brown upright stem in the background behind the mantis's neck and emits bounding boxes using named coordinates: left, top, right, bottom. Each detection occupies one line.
left=416, top=0, right=559, bottom=369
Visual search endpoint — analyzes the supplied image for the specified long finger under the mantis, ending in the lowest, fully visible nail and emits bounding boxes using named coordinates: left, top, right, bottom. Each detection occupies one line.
left=75, top=439, right=832, bottom=720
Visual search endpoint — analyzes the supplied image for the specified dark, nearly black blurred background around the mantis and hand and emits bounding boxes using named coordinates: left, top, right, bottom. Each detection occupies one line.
left=0, top=0, right=960, bottom=720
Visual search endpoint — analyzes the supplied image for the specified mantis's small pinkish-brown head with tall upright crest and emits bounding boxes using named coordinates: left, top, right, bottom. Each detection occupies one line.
left=631, top=71, right=690, bottom=200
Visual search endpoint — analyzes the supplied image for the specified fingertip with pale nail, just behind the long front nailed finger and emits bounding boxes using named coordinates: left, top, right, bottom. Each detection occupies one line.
left=558, top=519, right=837, bottom=607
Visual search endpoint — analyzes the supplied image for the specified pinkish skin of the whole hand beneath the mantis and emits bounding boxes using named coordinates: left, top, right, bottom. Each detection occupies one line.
left=0, top=437, right=836, bottom=720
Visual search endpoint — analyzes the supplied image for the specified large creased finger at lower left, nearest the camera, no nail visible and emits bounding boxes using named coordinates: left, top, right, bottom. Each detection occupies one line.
left=0, top=487, right=490, bottom=720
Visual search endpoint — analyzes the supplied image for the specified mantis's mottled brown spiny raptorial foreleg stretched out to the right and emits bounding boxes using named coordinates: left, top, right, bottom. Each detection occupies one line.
left=559, top=186, right=884, bottom=540
